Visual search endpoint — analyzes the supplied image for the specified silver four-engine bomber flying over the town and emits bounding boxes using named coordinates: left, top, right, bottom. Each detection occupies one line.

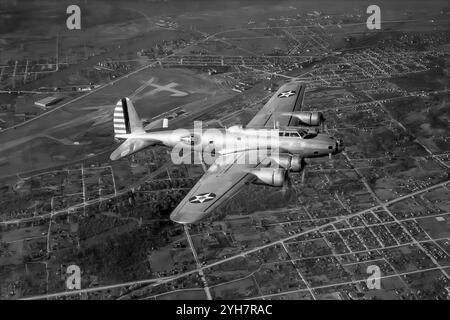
left=110, top=81, right=344, bottom=224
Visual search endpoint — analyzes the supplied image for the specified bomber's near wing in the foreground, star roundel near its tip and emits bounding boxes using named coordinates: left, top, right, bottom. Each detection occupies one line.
left=170, top=151, right=266, bottom=223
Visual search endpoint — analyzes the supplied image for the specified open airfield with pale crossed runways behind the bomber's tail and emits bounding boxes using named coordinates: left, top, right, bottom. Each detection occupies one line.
left=0, top=68, right=234, bottom=177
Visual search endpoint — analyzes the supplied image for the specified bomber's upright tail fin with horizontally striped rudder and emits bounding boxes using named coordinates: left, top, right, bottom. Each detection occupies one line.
left=114, top=98, right=145, bottom=136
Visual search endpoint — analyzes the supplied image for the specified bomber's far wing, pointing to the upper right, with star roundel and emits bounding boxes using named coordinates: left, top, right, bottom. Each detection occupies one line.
left=246, top=81, right=306, bottom=128
